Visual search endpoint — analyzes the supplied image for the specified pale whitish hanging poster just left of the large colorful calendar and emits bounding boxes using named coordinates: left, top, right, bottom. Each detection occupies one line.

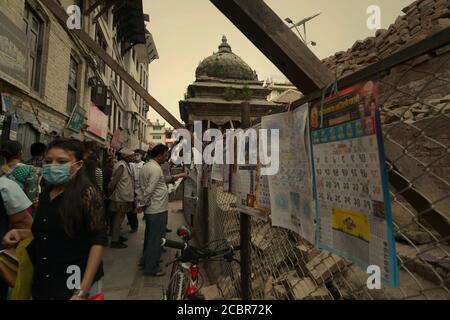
left=261, top=105, right=315, bottom=243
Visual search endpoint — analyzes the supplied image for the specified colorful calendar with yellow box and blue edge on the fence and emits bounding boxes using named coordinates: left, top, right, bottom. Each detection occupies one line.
left=309, top=81, right=399, bottom=287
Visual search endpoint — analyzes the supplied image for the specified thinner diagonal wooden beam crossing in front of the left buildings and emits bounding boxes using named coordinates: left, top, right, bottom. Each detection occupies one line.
left=41, top=0, right=184, bottom=129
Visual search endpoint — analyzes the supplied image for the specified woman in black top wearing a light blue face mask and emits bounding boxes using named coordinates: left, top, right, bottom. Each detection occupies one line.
left=4, top=140, right=108, bottom=300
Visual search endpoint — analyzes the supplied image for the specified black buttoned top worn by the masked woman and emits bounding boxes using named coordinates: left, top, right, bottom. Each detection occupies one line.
left=27, top=186, right=108, bottom=300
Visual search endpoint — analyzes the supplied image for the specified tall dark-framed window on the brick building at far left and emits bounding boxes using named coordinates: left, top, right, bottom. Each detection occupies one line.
left=24, top=4, right=44, bottom=92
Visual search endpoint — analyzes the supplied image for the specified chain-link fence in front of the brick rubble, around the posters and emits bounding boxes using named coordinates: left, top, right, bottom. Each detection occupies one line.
left=190, top=30, right=450, bottom=299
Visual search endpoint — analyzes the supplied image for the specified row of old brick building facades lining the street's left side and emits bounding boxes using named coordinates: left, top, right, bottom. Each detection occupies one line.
left=0, top=0, right=158, bottom=157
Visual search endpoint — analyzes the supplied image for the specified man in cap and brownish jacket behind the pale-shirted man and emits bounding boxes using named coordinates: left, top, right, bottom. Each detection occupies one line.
left=109, top=149, right=134, bottom=249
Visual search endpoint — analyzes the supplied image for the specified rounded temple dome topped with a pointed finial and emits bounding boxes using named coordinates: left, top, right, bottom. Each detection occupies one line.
left=195, top=36, right=258, bottom=81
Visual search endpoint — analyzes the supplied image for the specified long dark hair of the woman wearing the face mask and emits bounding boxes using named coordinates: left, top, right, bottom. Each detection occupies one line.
left=47, top=139, right=102, bottom=237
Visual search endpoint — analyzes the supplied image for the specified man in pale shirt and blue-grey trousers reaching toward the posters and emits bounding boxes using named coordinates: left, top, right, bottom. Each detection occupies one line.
left=139, top=144, right=186, bottom=277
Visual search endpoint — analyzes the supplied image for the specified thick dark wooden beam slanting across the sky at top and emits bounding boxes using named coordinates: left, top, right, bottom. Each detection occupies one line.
left=210, top=0, right=334, bottom=94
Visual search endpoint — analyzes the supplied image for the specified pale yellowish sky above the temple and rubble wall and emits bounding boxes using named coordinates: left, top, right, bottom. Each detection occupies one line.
left=143, top=0, right=413, bottom=125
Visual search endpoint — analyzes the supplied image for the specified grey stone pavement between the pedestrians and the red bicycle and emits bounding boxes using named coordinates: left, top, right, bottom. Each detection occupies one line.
left=103, top=201, right=185, bottom=300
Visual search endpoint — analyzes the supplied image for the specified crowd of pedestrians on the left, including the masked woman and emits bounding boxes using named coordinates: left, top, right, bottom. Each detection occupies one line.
left=0, top=139, right=187, bottom=300
